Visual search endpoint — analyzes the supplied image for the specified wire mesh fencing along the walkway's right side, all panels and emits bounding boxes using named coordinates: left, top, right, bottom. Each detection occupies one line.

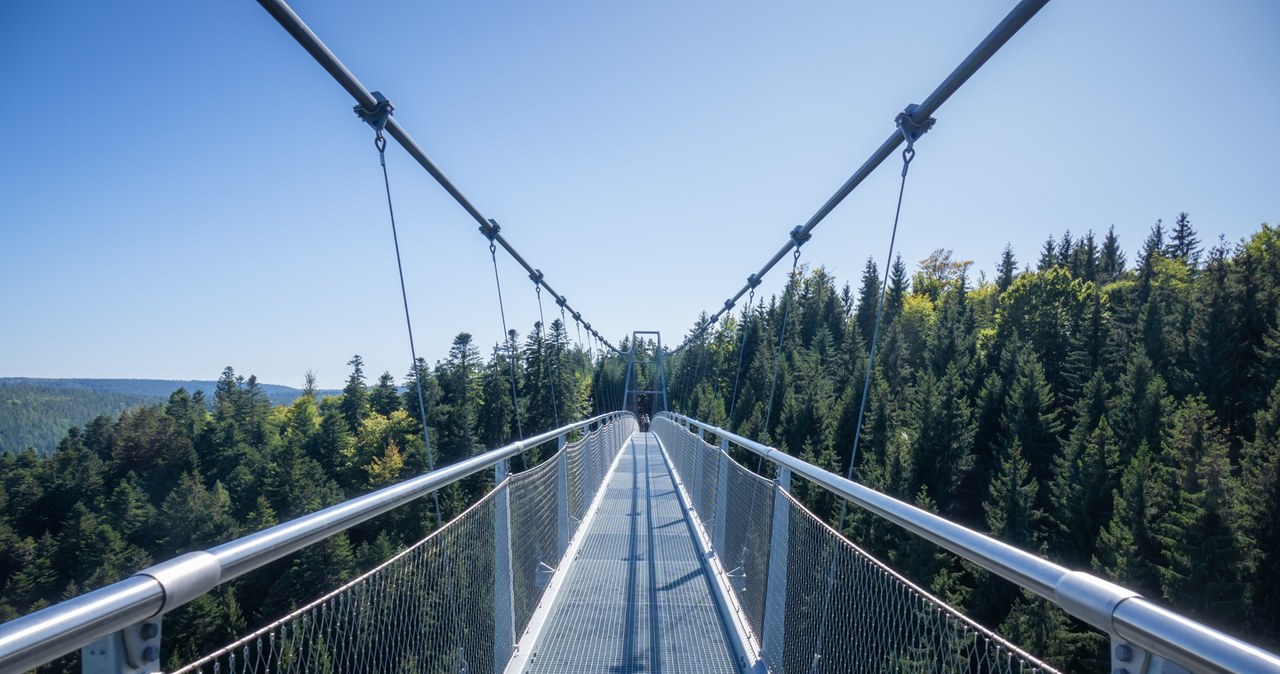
left=653, top=418, right=1053, bottom=674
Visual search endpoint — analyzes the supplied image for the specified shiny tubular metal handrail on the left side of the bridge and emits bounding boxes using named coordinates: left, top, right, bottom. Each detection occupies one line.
left=0, top=412, right=632, bottom=673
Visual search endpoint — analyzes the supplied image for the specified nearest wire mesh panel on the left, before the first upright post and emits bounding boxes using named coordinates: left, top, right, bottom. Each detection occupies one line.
left=178, top=492, right=494, bottom=674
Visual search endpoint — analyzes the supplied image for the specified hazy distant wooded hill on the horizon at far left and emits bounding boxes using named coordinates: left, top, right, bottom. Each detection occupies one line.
left=0, top=377, right=342, bottom=454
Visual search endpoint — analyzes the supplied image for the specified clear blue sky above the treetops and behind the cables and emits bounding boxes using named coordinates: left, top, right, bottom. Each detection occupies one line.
left=0, top=0, right=1280, bottom=386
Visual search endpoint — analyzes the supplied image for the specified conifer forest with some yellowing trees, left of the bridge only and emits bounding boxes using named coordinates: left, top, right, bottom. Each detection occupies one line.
left=0, top=320, right=622, bottom=671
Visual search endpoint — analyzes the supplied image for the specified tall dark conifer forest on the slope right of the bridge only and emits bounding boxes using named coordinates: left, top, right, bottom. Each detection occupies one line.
left=667, top=212, right=1280, bottom=671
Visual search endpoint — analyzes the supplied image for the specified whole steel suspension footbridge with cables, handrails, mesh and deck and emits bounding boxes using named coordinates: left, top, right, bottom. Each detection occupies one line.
left=0, top=0, right=1280, bottom=674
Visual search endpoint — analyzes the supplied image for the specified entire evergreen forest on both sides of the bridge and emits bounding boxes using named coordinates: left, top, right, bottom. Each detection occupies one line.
left=0, top=214, right=1280, bottom=671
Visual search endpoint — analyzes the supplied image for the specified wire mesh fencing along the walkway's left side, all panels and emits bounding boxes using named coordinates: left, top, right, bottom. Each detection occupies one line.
left=175, top=417, right=636, bottom=674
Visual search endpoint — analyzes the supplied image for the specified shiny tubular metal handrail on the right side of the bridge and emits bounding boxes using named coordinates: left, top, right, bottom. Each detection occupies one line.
left=658, top=412, right=1280, bottom=673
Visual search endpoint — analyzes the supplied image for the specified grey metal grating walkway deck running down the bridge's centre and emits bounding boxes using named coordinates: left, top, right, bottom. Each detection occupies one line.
left=527, top=432, right=737, bottom=674
